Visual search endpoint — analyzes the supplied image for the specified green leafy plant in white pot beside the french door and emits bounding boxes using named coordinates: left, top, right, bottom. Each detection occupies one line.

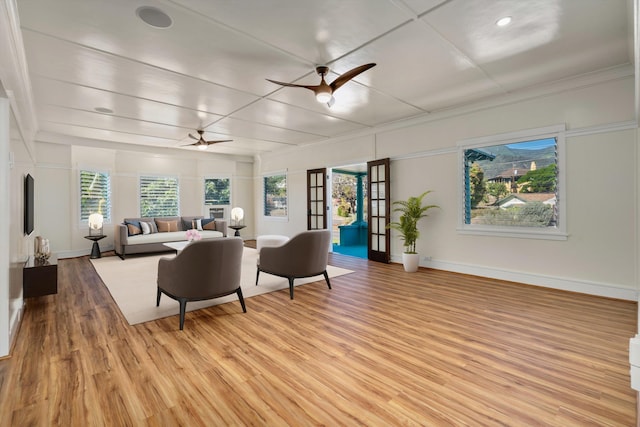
left=388, top=191, right=439, bottom=272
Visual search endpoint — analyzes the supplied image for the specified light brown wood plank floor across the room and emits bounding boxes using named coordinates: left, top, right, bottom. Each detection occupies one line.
left=0, top=246, right=637, bottom=427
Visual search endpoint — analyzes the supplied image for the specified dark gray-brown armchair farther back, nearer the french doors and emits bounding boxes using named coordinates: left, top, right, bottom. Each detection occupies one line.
left=256, top=230, right=331, bottom=299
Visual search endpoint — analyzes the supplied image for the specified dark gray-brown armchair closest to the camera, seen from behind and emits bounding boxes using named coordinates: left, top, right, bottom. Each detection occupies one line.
left=156, top=237, right=247, bottom=330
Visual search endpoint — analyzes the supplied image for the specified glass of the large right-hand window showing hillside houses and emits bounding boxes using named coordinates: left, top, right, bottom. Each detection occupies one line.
left=464, top=138, right=558, bottom=228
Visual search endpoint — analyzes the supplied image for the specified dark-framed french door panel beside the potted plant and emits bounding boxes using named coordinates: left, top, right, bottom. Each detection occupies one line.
left=367, top=158, right=391, bottom=263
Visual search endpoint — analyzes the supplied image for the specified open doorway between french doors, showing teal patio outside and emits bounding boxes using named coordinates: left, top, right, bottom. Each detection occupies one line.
left=330, top=164, right=368, bottom=258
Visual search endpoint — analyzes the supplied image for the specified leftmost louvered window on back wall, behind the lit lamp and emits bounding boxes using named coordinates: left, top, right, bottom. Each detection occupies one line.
left=80, top=170, right=111, bottom=223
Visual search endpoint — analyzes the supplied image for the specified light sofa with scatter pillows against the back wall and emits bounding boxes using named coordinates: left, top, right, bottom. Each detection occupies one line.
left=114, top=216, right=227, bottom=259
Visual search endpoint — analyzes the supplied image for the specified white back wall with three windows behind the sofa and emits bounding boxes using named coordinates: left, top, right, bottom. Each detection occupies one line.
left=36, top=142, right=253, bottom=257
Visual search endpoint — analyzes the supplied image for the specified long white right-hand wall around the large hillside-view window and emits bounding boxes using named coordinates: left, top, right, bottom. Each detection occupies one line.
left=255, top=78, right=638, bottom=300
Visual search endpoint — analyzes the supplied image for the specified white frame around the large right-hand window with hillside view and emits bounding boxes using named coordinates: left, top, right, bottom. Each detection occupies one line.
left=457, top=124, right=568, bottom=240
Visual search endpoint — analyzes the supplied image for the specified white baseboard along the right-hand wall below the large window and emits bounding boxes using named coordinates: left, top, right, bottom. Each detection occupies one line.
left=392, top=257, right=638, bottom=301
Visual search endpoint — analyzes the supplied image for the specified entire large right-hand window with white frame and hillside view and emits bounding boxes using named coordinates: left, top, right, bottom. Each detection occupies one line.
left=460, top=127, right=566, bottom=239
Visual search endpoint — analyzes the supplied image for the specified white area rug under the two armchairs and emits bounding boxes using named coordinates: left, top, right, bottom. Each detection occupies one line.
left=91, top=248, right=353, bottom=325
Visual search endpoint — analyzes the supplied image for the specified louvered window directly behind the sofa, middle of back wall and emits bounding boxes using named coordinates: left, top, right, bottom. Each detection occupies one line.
left=140, top=176, right=180, bottom=217
